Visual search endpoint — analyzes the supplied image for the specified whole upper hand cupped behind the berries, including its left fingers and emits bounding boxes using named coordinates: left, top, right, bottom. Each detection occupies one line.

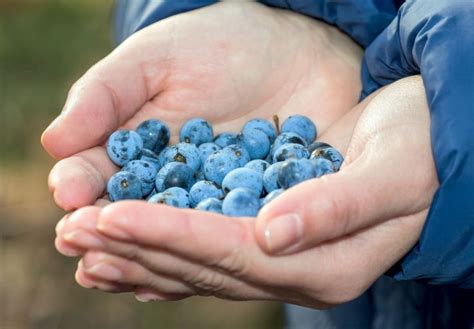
left=42, top=3, right=361, bottom=210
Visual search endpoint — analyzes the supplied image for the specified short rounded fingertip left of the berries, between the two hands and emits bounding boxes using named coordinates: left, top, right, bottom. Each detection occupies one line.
left=48, top=147, right=118, bottom=211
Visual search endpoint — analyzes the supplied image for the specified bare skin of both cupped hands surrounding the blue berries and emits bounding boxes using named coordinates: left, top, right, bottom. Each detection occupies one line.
left=43, top=3, right=437, bottom=308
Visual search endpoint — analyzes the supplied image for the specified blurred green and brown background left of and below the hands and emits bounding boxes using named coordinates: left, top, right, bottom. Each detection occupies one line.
left=0, top=0, right=284, bottom=329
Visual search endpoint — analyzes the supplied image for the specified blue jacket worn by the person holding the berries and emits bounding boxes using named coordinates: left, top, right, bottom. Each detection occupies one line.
left=115, top=0, right=474, bottom=317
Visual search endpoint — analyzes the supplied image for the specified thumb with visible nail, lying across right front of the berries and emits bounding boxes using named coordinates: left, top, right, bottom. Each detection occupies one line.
left=255, top=138, right=434, bottom=254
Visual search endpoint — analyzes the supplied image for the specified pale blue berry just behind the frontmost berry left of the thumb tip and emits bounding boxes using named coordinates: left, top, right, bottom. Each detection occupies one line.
left=222, top=168, right=263, bottom=196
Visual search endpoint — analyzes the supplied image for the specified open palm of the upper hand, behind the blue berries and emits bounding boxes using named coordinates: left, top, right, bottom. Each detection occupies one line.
left=122, top=3, right=360, bottom=140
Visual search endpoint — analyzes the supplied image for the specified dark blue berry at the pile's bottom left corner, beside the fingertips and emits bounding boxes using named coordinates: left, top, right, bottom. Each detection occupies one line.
left=107, top=171, right=143, bottom=201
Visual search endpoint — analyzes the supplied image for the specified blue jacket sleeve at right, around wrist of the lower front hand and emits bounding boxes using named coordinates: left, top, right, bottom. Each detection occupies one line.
left=362, top=0, right=474, bottom=288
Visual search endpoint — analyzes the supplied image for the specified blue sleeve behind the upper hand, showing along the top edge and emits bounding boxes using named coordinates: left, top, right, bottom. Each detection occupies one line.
left=114, top=0, right=400, bottom=47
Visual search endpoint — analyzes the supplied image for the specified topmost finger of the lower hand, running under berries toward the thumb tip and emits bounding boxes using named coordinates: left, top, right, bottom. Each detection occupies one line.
left=97, top=201, right=248, bottom=261
